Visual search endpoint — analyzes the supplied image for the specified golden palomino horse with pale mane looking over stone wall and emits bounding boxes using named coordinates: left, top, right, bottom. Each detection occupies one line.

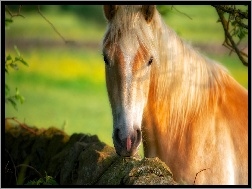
left=103, top=5, right=248, bottom=184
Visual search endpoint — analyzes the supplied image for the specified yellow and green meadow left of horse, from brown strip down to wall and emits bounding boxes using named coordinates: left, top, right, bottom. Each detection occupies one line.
left=5, top=47, right=112, bottom=145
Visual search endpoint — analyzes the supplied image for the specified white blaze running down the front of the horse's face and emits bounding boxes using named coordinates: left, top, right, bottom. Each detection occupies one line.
left=116, top=40, right=148, bottom=137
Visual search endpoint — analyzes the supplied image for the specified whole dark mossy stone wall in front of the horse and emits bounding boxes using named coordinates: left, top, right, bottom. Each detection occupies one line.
left=4, top=122, right=177, bottom=186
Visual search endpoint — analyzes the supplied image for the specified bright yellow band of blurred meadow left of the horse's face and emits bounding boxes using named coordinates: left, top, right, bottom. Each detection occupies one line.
left=7, top=48, right=105, bottom=83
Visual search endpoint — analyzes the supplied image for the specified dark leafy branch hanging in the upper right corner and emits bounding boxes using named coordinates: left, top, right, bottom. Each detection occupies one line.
left=212, top=5, right=248, bottom=66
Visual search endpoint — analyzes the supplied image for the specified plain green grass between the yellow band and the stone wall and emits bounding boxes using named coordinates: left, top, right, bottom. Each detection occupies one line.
left=5, top=67, right=112, bottom=145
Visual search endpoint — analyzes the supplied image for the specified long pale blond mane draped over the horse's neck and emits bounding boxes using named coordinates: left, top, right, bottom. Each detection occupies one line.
left=150, top=23, right=227, bottom=140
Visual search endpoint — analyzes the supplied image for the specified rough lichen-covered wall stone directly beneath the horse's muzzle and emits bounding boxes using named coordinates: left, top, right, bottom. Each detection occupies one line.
left=96, top=157, right=176, bottom=185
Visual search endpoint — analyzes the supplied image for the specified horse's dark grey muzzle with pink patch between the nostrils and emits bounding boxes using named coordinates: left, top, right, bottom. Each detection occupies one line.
left=113, top=129, right=142, bottom=157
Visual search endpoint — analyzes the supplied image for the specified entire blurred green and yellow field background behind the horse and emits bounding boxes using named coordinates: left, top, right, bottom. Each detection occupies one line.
left=5, top=5, right=248, bottom=149
